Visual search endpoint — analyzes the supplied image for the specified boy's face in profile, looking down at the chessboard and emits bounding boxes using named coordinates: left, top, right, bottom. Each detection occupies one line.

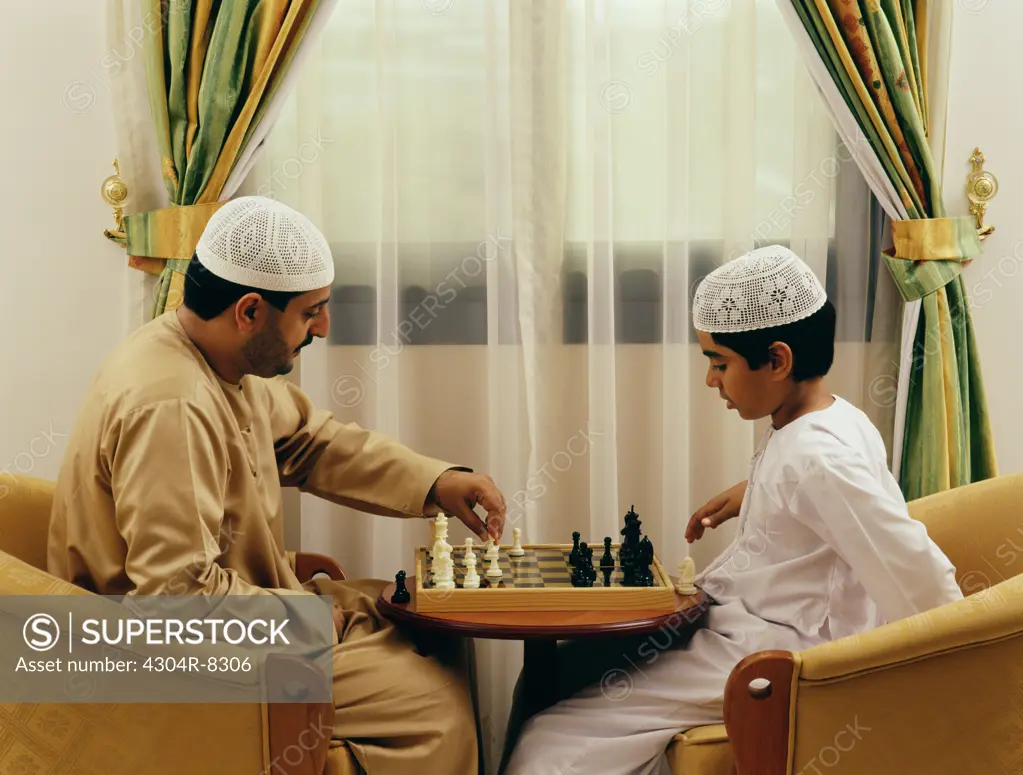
left=697, top=331, right=791, bottom=420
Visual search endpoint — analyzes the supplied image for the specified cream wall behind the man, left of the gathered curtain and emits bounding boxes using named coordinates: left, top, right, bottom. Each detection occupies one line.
left=0, top=0, right=128, bottom=477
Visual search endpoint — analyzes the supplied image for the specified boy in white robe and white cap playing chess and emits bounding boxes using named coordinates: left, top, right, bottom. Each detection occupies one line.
left=507, top=246, right=962, bottom=775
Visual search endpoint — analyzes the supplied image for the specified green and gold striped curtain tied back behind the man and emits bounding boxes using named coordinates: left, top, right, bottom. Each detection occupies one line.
left=134, top=0, right=320, bottom=316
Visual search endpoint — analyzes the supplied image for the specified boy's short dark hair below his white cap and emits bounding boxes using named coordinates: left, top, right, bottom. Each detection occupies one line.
left=712, top=301, right=835, bottom=382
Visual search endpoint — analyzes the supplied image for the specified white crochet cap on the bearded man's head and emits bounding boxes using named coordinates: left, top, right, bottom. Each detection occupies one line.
left=195, top=196, right=333, bottom=293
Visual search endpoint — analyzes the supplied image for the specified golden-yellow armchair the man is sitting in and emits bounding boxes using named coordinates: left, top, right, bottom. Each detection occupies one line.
left=0, top=475, right=361, bottom=775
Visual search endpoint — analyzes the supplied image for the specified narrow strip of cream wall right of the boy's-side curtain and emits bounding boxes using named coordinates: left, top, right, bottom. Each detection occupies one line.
left=944, top=0, right=1023, bottom=473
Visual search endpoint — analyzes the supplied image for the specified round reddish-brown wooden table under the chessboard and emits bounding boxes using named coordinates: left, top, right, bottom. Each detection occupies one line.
left=376, top=576, right=708, bottom=715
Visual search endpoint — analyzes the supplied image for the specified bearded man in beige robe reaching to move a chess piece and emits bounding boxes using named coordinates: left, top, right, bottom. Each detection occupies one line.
left=48, top=197, right=505, bottom=775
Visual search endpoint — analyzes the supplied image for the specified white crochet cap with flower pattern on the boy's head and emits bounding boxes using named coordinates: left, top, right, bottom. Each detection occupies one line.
left=693, top=245, right=828, bottom=333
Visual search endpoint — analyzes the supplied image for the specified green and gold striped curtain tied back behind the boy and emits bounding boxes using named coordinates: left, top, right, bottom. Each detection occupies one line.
left=782, top=0, right=997, bottom=500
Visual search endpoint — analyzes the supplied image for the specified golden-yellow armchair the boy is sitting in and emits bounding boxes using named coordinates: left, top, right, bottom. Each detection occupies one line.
left=668, top=474, right=1023, bottom=775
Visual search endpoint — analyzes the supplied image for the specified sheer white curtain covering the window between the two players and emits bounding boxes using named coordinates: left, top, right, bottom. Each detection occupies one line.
left=241, top=0, right=876, bottom=770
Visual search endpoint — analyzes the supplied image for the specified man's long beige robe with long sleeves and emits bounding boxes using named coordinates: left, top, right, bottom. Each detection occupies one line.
left=48, top=313, right=477, bottom=775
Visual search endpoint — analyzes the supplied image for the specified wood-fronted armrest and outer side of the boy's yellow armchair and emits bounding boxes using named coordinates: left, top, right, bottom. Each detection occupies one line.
left=724, top=577, right=1023, bottom=775
